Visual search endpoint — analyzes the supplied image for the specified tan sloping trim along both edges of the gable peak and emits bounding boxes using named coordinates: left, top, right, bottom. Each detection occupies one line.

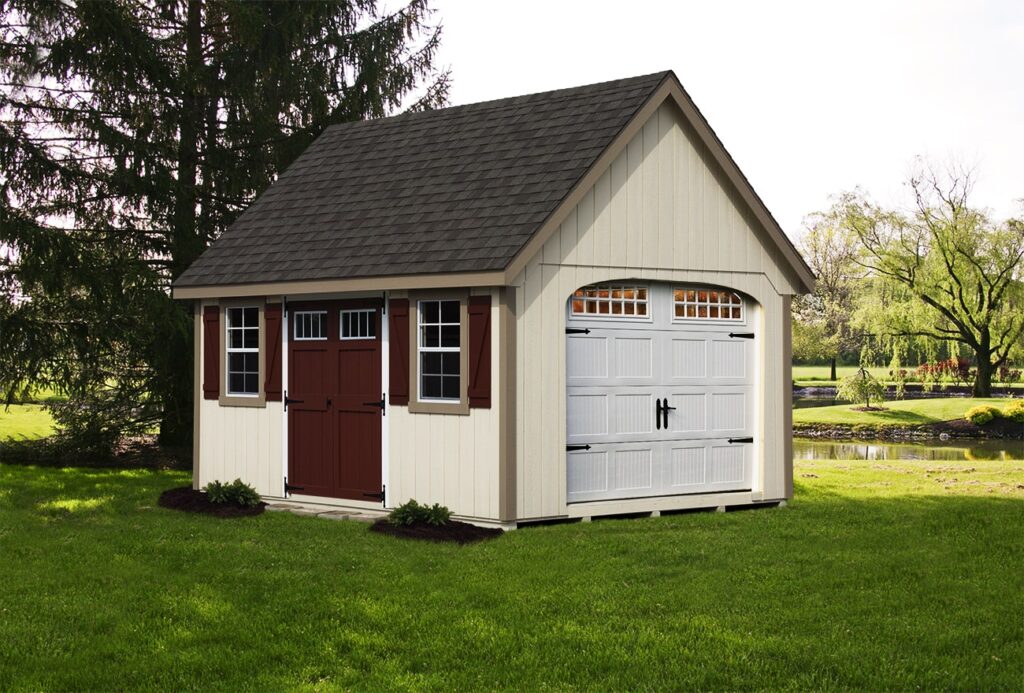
left=501, top=75, right=816, bottom=293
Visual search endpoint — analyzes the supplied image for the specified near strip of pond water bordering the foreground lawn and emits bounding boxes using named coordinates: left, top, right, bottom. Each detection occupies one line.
left=793, top=438, right=1024, bottom=461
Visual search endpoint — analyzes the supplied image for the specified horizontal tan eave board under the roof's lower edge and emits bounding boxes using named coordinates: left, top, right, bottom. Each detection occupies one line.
left=173, top=271, right=505, bottom=299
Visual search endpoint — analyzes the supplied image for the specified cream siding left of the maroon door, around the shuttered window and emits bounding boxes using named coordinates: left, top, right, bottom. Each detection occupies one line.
left=193, top=299, right=284, bottom=497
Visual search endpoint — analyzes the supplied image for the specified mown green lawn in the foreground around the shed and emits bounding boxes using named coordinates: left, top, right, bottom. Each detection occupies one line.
left=0, top=461, right=1024, bottom=691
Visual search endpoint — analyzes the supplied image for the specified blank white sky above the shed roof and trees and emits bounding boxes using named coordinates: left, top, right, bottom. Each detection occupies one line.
left=433, top=0, right=1024, bottom=235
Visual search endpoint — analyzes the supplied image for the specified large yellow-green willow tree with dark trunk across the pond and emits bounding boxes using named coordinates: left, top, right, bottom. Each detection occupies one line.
left=843, top=167, right=1024, bottom=397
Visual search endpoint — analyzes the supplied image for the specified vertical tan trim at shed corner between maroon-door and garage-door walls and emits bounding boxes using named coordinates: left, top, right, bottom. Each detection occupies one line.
left=498, top=287, right=516, bottom=522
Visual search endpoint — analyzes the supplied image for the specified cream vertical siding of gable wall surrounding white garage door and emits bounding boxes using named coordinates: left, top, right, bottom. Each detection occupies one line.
left=512, top=102, right=799, bottom=520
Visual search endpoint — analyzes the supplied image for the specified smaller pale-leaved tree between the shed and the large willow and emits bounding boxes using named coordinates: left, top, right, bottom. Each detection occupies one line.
left=794, top=204, right=864, bottom=380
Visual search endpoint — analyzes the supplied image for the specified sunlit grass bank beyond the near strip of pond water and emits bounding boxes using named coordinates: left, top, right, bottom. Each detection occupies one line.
left=793, top=397, right=1010, bottom=426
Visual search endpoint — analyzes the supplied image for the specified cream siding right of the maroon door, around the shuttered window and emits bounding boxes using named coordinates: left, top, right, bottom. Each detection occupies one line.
left=387, top=289, right=502, bottom=522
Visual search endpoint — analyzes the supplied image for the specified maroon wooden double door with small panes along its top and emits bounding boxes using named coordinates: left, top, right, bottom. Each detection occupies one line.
left=287, top=300, right=384, bottom=502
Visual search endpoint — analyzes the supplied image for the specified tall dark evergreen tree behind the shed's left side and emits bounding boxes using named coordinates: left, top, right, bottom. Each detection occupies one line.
left=0, top=0, right=449, bottom=445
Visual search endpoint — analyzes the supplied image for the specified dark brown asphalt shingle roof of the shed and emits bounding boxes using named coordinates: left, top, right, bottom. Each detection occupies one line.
left=175, top=72, right=671, bottom=287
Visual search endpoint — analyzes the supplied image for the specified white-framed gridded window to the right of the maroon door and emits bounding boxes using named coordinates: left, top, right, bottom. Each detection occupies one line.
left=417, top=300, right=462, bottom=402
